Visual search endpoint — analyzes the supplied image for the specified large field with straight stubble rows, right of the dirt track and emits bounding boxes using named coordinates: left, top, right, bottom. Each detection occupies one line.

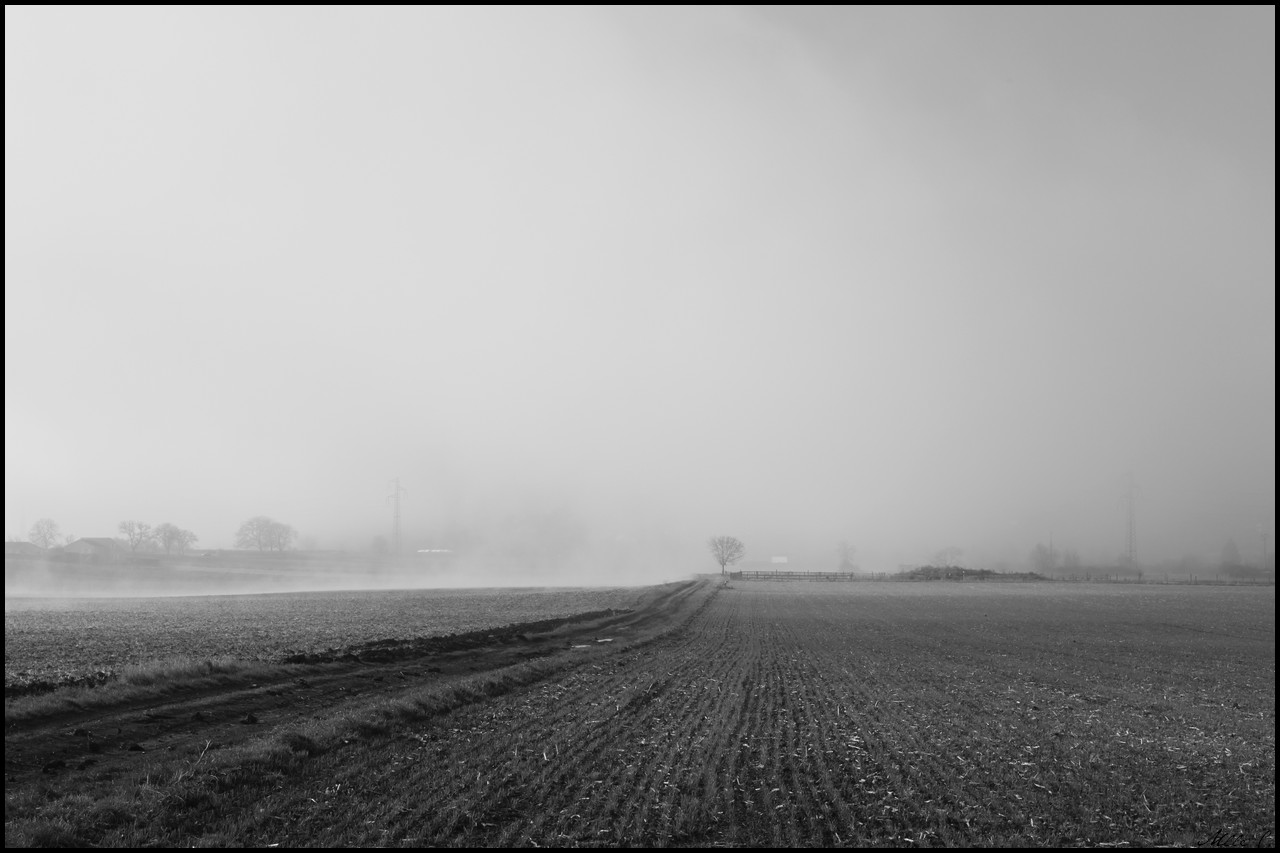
left=6, top=583, right=1275, bottom=847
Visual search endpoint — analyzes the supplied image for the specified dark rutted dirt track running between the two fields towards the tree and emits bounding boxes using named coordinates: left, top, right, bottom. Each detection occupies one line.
left=5, top=596, right=663, bottom=788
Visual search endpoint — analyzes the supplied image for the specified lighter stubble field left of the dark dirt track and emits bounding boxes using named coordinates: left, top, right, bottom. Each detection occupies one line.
left=5, top=588, right=650, bottom=692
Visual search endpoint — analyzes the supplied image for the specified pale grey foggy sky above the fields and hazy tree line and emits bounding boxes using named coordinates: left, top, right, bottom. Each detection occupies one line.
left=5, top=6, right=1275, bottom=579
